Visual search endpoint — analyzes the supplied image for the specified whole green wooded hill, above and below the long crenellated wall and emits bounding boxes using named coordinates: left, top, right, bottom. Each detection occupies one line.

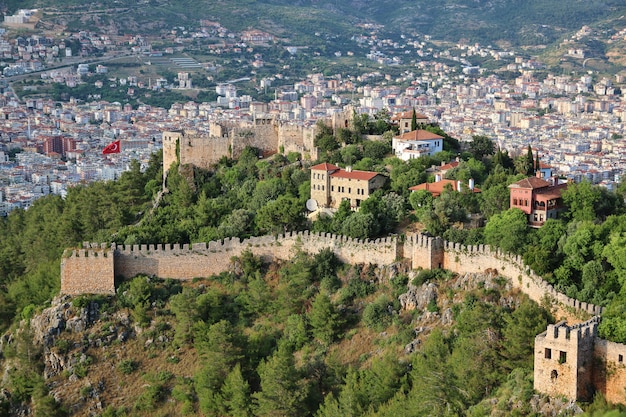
left=0, top=119, right=626, bottom=417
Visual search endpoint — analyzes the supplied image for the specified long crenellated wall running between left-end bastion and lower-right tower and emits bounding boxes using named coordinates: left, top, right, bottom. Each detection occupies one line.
left=65, top=231, right=602, bottom=315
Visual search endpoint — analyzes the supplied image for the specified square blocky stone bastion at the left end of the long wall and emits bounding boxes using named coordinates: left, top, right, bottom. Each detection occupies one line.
left=61, top=245, right=115, bottom=295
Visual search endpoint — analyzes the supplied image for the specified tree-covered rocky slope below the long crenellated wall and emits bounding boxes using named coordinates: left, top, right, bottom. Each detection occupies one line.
left=4, top=250, right=559, bottom=417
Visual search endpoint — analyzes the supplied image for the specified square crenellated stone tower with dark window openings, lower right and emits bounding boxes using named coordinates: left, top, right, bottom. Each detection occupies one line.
left=534, top=317, right=598, bottom=400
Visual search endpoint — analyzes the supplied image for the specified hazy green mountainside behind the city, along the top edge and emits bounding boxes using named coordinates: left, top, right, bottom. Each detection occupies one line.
left=0, top=0, right=626, bottom=45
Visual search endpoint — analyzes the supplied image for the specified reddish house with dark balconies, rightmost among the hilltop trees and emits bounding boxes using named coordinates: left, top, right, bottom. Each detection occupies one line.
left=509, top=173, right=567, bottom=228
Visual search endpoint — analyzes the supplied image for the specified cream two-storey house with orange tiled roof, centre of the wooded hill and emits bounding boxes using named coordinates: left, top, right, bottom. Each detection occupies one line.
left=311, top=162, right=387, bottom=209
